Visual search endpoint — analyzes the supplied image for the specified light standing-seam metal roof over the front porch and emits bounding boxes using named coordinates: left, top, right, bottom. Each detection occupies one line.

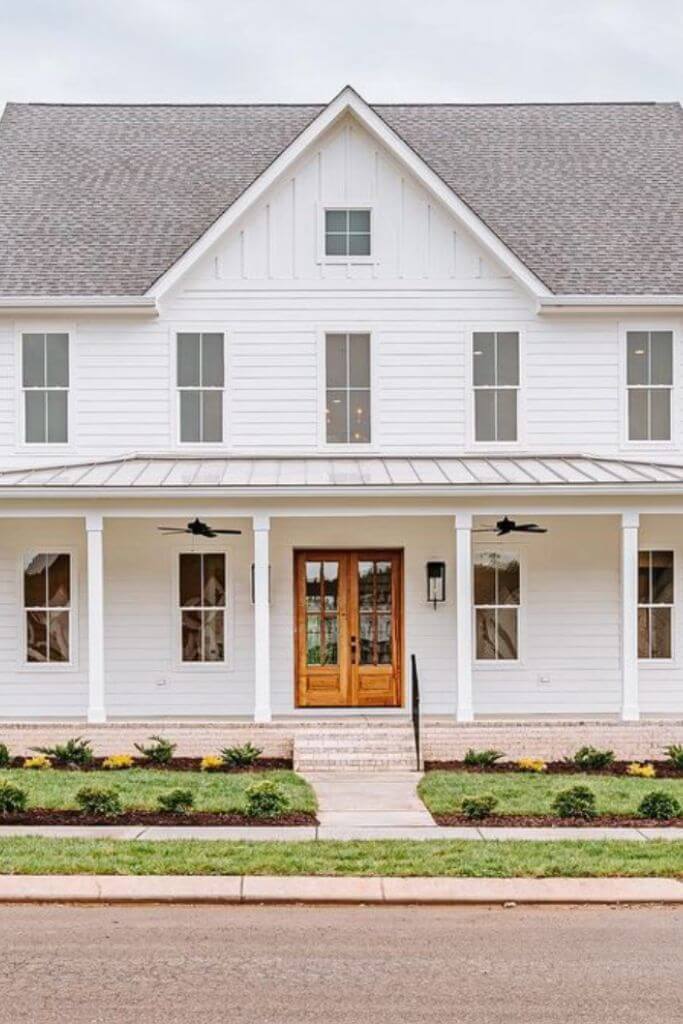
left=0, top=454, right=683, bottom=497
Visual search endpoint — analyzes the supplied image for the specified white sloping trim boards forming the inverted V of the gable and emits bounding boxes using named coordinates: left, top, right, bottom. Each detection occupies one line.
left=146, top=86, right=552, bottom=299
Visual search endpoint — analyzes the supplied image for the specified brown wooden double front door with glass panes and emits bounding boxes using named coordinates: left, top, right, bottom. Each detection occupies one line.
left=294, top=551, right=403, bottom=708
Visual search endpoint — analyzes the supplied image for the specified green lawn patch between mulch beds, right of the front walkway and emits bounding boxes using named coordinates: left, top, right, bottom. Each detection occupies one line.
left=418, top=771, right=683, bottom=814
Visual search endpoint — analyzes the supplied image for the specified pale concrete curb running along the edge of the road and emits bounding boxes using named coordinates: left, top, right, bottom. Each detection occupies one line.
left=0, top=874, right=683, bottom=906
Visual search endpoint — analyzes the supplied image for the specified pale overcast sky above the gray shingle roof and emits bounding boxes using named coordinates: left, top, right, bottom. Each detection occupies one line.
left=0, top=0, right=683, bottom=109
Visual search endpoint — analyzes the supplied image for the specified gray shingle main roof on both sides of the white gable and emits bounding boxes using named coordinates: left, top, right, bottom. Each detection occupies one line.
left=0, top=103, right=683, bottom=295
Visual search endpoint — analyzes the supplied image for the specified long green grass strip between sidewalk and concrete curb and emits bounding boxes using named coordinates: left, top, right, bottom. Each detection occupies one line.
left=0, top=837, right=683, bottom=878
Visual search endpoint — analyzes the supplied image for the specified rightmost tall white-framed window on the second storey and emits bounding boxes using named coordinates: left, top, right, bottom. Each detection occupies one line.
left=626, top=331, right=674, bottom=441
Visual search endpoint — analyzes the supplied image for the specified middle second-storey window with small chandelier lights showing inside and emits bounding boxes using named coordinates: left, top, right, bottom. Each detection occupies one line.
left=325, top=334, right=371, bottom=444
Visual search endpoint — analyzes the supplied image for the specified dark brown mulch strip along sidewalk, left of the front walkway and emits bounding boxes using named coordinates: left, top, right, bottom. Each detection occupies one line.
left=0, top=807, right=317, bottom=827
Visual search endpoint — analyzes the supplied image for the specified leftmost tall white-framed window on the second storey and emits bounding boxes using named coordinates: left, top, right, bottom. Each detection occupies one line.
left=22, top=334, right=69, bottom=444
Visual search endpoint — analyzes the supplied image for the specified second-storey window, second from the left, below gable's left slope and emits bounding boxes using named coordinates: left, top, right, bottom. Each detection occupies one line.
left=177, top=333, right=225, bottom=444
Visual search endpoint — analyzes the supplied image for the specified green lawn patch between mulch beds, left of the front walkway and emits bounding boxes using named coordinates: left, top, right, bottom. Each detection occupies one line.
left=0, top=768, right=316, bottom=813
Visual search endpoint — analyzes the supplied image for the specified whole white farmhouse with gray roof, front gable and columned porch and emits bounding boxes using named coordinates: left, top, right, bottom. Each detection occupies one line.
left=0, top=88, right=683, bottom=764
